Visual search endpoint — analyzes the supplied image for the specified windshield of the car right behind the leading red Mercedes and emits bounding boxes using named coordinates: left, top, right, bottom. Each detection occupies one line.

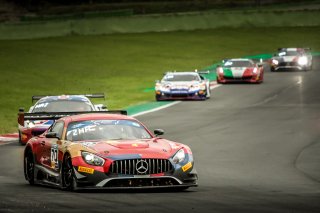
left=32, top=100, right=93, bottom=112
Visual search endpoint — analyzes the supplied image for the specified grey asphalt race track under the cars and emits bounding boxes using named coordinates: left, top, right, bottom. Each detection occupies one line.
left=0, top=58, right=320, bottom=213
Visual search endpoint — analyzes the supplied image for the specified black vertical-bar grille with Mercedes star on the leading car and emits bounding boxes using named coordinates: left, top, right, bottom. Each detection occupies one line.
left=110, top=159, right=173, bottom=175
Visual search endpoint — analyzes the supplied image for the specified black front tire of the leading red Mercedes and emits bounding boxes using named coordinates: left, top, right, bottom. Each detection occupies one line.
left=61, top=154, right=77, bottom=191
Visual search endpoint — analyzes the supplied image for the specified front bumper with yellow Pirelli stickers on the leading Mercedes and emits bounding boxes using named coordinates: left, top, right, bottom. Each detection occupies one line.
left=73, top=159, right=198, bottom=189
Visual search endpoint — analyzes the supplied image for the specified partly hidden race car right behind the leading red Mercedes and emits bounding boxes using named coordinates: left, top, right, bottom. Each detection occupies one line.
left=18, top=93, right=107, bottom=145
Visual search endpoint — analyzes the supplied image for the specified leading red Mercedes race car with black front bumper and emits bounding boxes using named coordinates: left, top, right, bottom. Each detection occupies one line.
left=20, top=111, right=198, bottom=190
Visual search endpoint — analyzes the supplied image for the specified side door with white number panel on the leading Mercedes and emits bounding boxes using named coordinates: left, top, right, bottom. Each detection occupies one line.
left=41, top=121, right=64, bottom=171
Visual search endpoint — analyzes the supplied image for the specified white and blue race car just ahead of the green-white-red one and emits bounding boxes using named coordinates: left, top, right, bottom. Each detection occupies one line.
left=155, top=72, right=210, bottom=101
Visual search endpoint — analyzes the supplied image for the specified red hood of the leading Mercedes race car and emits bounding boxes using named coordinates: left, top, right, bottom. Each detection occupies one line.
left=82, top=138, right=182, bottom=158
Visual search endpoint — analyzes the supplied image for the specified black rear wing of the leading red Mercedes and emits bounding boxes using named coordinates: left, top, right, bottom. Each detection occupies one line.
left=18, top=108, right=128, bottom=126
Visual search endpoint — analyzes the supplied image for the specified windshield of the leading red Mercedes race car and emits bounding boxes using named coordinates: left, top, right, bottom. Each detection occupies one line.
left=66, top=120, right=151, bottom=141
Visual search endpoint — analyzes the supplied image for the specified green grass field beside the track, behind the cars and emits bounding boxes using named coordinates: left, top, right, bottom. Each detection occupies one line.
left=0, top=27, right=320, bottom=133
